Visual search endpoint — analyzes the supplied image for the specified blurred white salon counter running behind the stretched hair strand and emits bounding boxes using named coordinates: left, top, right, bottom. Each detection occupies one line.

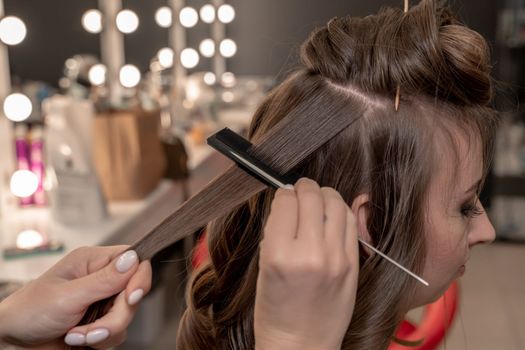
left=0, top=111, right=251, bottom=282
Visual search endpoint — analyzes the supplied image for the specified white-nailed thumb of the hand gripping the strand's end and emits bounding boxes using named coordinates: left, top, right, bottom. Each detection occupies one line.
left=68, top=250, right=139, bottom=307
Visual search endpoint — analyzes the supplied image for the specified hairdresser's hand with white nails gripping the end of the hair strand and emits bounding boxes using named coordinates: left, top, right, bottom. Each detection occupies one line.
left=0, top=246, right=151, bottom=349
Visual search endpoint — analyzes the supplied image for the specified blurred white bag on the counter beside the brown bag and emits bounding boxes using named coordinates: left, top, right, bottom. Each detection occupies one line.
left=43, top=95, right=107, bottom=225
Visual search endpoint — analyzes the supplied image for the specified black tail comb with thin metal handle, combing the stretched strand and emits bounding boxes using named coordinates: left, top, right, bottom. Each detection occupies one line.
left=207, top=128, right=429, bottom=286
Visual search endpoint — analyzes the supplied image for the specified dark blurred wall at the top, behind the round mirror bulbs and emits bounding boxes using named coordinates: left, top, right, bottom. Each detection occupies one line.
left=4, top=0, right=497, bottom=84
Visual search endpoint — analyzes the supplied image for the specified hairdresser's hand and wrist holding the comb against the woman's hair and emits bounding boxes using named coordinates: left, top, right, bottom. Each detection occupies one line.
left=255, top=179, right=359, bottom=350
